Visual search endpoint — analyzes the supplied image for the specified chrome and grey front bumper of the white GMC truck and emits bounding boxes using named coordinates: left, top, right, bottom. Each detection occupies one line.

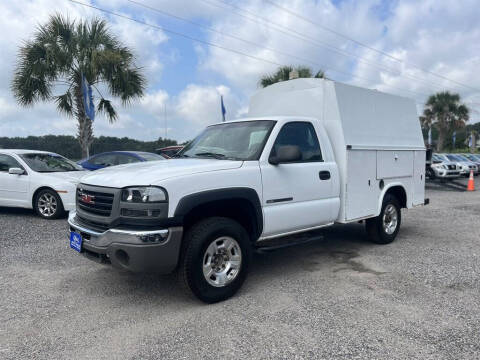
left=68, top=211, right=183, bottom=274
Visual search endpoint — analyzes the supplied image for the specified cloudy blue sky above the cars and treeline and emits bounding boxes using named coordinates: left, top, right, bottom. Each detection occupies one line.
left=0, top=0, right=480, bottom=142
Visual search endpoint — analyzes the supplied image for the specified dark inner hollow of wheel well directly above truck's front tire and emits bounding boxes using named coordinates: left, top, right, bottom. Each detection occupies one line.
left=183, top=198, right=262, bottom=241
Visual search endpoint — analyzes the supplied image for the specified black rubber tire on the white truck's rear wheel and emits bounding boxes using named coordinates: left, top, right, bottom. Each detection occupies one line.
left=365, top=194, right=402, bottom=245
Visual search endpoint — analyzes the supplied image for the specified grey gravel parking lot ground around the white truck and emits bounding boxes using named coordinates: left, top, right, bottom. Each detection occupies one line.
left=0, top=180, right=480, bottom=359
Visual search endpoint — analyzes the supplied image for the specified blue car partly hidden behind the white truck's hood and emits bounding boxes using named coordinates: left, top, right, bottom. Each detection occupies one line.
left=78, top=151, right=165, bottom=170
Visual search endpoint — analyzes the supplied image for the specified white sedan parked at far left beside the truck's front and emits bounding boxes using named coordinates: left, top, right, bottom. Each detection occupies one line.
left=0, top=149, right=88, bottom=219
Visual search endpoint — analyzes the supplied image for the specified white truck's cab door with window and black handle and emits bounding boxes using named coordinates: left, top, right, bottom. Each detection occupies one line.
left=260, top=121, right=338, bottom=237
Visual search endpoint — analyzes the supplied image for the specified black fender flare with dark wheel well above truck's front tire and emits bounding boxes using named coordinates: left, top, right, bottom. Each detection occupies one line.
left=174, top=187, right=263, bottom=241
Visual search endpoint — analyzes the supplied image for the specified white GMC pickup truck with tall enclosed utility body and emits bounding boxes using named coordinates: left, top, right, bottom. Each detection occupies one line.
left=69, top=79, right=426, bottom=302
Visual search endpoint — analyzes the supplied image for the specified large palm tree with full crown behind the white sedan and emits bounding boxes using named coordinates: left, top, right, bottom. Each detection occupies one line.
left=11, top=14, right=146, bottom=156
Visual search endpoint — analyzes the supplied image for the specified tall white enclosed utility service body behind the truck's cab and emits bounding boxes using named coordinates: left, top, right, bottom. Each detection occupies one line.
left=248, top=79, right=426, bottom=223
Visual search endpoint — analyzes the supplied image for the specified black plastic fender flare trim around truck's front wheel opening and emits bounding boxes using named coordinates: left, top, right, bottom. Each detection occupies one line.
left=174, top=187, right=263, bottom=235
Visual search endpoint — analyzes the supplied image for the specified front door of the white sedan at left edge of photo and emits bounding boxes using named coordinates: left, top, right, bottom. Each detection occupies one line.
left=0, top=154, right=31, bottom=207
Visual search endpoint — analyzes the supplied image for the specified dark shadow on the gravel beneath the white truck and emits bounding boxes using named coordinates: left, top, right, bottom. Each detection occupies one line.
left=77, top=224, right=383, bottom=308
